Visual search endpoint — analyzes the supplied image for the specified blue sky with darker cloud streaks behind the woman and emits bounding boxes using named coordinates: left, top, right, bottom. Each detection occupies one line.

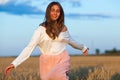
left=0, top=0, right=120, bottom=56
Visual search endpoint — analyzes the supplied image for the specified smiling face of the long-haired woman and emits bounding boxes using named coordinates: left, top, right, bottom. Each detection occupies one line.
left=50, top=5, right=60, bottom=21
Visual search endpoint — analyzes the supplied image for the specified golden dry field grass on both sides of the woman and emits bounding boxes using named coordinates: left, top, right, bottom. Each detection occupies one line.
left=0, top=56, right=120, bottom=80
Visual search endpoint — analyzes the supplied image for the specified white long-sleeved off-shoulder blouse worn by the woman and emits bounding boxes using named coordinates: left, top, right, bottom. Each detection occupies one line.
left=12, top=26, right=87, bottom=67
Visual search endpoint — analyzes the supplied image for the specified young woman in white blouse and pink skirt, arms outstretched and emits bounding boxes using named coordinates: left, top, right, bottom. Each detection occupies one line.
left=5, top=2, right=88, bottom=80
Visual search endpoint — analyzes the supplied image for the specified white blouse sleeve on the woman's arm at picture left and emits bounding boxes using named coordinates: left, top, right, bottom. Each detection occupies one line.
left=11, top=28, right=41, bottom=68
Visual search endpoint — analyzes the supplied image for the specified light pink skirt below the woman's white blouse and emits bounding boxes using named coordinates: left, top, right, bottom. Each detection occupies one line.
left=40, top=51, right=70, bottom=80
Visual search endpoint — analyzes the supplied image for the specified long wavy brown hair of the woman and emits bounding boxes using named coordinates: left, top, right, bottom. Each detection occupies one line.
left=41, top=2, right=64, bottom=40
